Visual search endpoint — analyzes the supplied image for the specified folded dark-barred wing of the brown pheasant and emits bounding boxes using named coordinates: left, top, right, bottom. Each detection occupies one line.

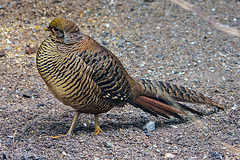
left=75, top=38, right=131, bottom=100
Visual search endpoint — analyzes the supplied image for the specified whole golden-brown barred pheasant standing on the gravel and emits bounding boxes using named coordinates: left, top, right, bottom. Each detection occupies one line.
left=36, top=18, right=225, bottom=136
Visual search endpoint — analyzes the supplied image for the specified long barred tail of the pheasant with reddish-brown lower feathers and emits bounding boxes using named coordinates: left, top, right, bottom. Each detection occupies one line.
left=130, top=79, right=225, bottom=119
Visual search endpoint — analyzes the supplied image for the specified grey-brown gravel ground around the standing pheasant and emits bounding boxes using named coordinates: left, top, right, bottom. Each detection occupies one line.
left=0, top=0, right=240, bottom=160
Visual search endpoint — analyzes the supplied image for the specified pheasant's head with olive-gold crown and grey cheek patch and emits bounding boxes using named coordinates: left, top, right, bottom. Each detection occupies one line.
left=44, top=18, right=82, bottom=44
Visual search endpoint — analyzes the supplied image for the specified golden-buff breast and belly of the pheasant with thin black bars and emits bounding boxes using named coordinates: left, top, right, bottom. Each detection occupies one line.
left=37, top=38, right=111, bottom=113
